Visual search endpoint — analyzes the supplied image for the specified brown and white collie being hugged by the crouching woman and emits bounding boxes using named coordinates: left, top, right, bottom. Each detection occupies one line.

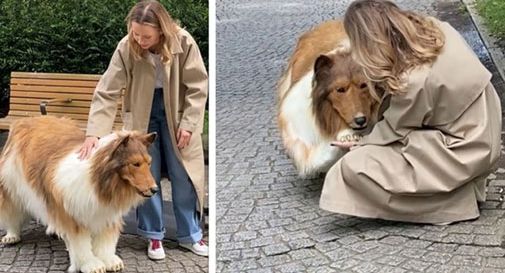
left=277, top=21, right=378, bottom=177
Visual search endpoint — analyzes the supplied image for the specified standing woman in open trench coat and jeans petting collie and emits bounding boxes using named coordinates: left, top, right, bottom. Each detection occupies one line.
left=80, top=1, right=208, bottom=260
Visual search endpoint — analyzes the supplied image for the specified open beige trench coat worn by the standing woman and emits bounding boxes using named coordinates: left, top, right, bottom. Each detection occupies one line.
left=87, top=29, right=208, bottom=211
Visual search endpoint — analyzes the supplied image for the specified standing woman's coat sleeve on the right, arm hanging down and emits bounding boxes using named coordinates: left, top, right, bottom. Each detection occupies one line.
left=179, top=35, right=208, bottom=132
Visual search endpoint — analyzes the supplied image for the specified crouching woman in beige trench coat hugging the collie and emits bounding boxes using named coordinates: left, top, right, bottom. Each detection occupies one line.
left=320, top=0, right=501, bottom=224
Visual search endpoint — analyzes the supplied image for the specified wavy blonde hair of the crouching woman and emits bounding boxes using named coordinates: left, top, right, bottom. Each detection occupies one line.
left=344, top=0, right=445, bottom=95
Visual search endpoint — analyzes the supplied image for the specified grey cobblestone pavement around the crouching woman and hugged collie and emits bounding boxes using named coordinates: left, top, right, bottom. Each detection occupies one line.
left=216, top=0, right=505, bottom=272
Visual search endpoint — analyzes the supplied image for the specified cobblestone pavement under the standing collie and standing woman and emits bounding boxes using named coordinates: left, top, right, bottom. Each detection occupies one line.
left=0, top=192, right=209, bottom=273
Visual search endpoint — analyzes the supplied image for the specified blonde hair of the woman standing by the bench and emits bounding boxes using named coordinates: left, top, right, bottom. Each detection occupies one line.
left=126, top=0, right=177, bottom=63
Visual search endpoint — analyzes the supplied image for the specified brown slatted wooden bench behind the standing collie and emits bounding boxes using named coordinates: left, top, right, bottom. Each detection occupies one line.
left=0, top=72, right=122, bottom=130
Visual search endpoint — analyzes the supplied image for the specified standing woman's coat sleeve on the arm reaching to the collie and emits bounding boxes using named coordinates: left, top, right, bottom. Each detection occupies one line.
left=86, top=39, right=127, bottom=137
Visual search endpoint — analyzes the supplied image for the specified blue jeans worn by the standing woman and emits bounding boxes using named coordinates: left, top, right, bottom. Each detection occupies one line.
left=137, top=89, right=202, bottom=243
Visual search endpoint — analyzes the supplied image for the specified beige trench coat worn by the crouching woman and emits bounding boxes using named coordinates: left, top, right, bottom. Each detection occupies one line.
left=320, top=19, right=501, bottom=223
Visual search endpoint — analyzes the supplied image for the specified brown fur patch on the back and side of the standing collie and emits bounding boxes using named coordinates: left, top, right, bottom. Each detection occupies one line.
left=3, top=118, right=85, bottom=233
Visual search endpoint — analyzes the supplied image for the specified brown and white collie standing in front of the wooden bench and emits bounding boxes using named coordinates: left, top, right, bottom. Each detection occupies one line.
left=0, top=116, right=158, bottom=273
